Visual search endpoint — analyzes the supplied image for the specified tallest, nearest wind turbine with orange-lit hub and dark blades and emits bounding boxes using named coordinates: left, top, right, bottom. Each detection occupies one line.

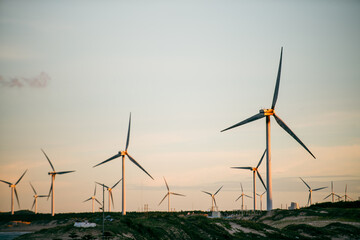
left=221, top=47, right=315, bottom=211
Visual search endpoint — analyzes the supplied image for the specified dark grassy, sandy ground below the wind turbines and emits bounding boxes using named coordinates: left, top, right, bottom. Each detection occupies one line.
left=0, top=201, right=360, bottom=239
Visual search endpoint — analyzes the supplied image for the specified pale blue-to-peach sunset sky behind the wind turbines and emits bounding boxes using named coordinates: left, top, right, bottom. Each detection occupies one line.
left=0, top=0, right=360, bottom=213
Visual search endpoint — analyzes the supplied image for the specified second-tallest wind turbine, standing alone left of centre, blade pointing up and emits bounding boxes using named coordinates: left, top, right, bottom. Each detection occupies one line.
left=94, top=113, right=154, bottom=215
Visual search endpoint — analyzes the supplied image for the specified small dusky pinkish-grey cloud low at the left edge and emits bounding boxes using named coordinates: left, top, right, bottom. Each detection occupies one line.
left=0, top=72, right=51, bottom=88
